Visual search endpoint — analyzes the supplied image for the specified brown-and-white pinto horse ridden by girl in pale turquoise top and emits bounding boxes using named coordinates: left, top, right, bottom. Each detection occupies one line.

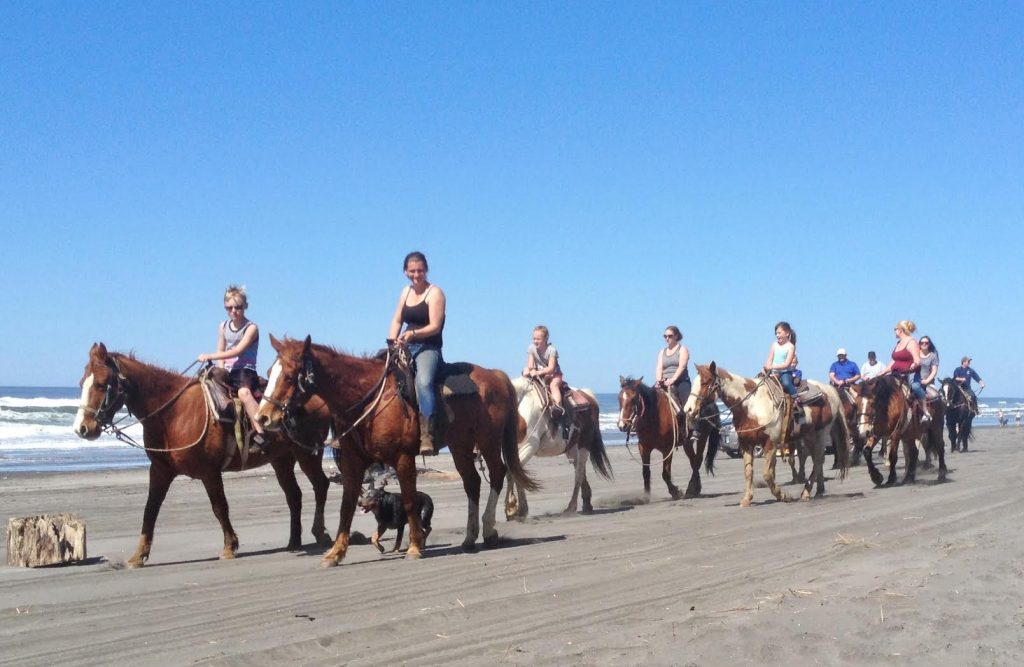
left=685, top=362, right=849, bottom=507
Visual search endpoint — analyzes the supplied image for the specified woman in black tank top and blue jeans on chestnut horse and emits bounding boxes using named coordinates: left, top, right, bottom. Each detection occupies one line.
left=387, top=252, right=445, bottom=456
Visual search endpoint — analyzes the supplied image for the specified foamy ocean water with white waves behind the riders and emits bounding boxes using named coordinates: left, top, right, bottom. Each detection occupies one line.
left=0, top=386, right=1024, bottom=475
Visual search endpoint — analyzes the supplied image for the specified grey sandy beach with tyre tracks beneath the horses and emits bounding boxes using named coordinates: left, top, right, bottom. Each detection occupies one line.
left=0, top=428, right=1024, bottom=666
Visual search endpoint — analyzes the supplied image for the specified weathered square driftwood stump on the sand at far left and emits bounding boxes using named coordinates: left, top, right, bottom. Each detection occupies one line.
left=7, top=514, right=85, bottom=568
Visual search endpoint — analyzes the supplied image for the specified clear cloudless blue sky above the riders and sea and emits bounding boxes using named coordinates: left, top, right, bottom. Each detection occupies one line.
left=0, top=2, right=1024, bottom=397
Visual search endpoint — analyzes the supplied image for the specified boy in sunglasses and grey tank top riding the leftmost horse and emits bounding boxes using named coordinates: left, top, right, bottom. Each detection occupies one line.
left=196, top=285, right=264, bottom=450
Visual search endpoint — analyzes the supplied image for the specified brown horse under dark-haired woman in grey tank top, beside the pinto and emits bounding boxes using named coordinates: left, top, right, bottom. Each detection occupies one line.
left=618, top=376, right=722, bottom=500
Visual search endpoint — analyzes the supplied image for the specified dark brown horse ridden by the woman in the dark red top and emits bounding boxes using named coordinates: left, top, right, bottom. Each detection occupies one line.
left=857, top=375, right=946, bottom=487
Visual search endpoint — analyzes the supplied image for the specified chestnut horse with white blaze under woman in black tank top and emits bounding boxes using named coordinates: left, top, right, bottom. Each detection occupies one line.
left=257, top=336, right=539, bottom=567
